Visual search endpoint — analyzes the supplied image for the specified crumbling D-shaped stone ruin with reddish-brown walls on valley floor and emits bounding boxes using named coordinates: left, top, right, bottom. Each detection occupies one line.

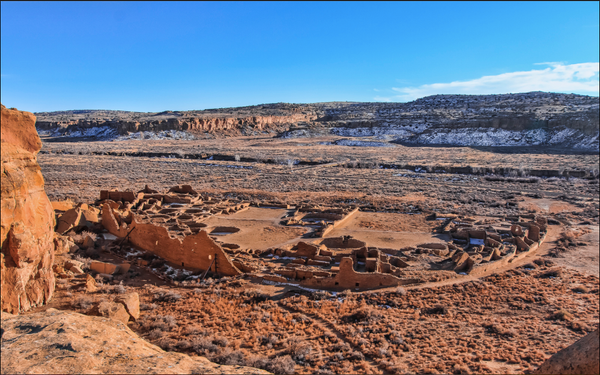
left=50, top=185, right=548, bottom=290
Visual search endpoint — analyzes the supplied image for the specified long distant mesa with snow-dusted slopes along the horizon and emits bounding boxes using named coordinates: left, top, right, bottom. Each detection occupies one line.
left=36, top=92, right=600, bottom=151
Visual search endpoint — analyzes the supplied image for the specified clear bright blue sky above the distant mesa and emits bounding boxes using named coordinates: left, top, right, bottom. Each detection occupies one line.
left=1, top=1, right=600, bottom=112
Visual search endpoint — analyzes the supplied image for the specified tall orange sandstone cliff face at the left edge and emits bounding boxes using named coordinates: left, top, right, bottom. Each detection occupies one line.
left=0, top=106, right=55, bottom=313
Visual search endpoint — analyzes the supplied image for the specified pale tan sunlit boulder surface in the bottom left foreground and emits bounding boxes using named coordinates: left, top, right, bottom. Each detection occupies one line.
left=1, top=309, right=268, bottom=374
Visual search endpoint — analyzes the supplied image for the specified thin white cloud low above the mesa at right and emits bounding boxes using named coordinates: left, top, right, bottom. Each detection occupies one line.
left=386, top=62, right=600, bottom=101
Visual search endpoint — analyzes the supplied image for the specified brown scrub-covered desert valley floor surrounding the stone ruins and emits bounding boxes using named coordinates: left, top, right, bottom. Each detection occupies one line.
left=21, top=137, right=600, bottom=374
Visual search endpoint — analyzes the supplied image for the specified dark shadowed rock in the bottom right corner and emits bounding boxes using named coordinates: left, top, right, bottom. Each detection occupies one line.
left=534, top=330, right=600, bottom=375
